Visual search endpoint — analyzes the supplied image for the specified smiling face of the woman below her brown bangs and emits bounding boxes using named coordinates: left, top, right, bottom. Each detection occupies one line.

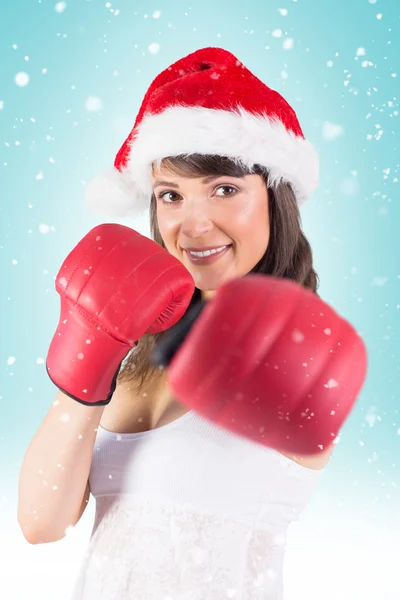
left=153, top=168, right=270, bottom=299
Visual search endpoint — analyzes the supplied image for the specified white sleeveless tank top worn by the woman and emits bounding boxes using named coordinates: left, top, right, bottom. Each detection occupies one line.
left=73, top=411, right=321, bottom=600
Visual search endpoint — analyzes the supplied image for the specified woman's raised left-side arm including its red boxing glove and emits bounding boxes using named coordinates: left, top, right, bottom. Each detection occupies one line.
left=18, top=223, right=194, bottom=543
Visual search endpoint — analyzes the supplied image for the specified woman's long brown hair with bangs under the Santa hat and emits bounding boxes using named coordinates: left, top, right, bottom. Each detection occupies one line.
left=117, top=154, right=319, bottom=391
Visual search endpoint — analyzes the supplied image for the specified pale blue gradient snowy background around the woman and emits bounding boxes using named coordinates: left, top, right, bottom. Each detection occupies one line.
left=0, top=0, right=400, bottom=600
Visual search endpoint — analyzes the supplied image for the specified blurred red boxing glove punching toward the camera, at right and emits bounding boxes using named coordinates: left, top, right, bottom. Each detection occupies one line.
left=164, top=275, right=367, bottom=455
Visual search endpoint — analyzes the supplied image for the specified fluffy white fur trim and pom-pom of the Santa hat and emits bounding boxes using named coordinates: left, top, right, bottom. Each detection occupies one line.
left=86, top=106, right=319, bottom=216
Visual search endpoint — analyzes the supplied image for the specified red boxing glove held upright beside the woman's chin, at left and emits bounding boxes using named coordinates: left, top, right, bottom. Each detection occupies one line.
left=46, top=223, right=194, bottom=405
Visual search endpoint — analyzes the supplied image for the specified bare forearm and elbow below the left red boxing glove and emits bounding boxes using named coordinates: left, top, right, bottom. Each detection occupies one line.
left=18, top=392, right=104, bottom=544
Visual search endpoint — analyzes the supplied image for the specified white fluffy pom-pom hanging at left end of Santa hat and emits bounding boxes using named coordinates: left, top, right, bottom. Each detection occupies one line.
left=85, top=168, right=150, bottom=218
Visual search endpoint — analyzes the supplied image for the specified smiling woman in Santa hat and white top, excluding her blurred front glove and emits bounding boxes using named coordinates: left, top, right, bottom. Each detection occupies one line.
left=19, top=48, right=368, bottom=600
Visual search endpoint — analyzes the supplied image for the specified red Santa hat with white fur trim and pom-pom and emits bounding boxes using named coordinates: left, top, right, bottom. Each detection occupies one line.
left=86, top=48, right=319, bottom=217
